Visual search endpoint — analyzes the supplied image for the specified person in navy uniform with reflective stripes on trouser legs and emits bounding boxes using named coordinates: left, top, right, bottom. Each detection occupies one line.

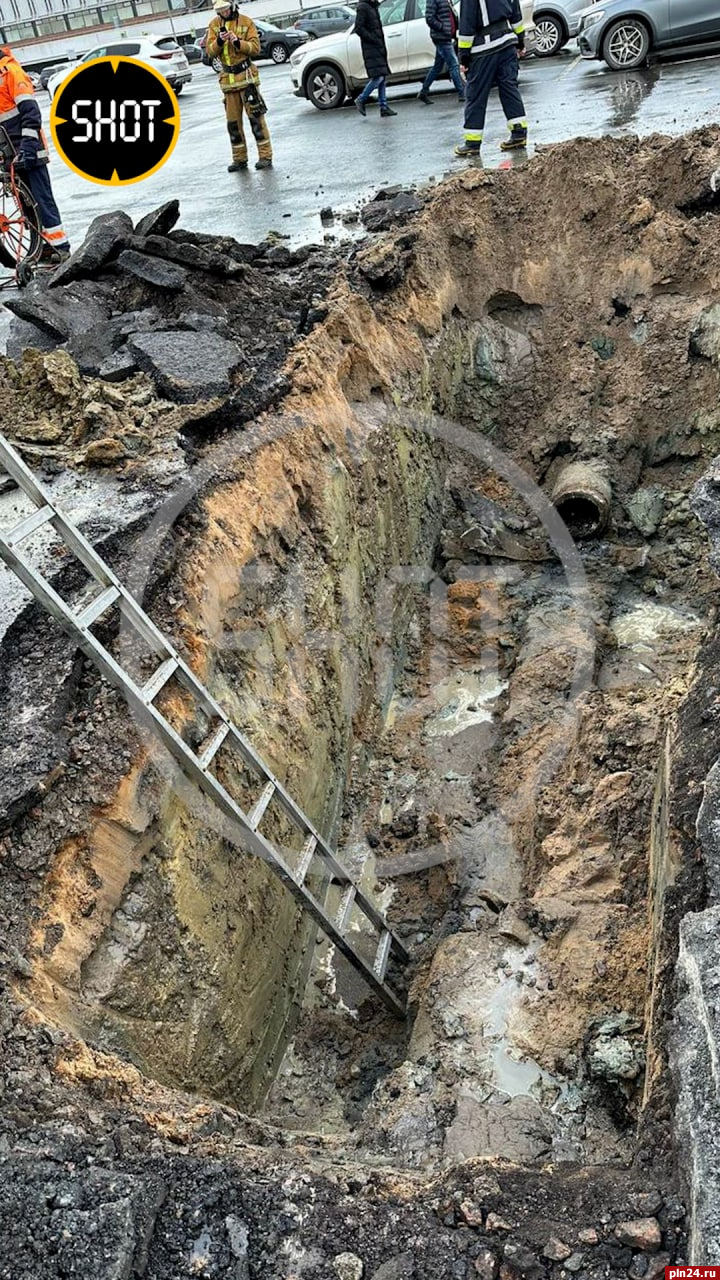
left=455, top=0, right=528, bottom=157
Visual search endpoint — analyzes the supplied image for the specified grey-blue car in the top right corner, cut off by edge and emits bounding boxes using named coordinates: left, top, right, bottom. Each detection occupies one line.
left=578, top=0, right=720, bottom=70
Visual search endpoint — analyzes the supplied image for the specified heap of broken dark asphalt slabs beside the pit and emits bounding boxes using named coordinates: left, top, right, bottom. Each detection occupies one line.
left=3, top=192, right=337, bottom=448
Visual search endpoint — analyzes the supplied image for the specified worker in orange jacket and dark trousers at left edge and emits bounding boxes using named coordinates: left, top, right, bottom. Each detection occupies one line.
left=0, top=45, right=70, bottom=262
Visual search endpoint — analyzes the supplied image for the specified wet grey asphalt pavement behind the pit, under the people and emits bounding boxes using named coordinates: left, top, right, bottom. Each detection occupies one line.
left=26, top=46, right=720, bottom=252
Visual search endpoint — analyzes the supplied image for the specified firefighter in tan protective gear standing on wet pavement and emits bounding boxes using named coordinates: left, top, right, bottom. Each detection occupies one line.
left=205, top=0, right=273, bottom=173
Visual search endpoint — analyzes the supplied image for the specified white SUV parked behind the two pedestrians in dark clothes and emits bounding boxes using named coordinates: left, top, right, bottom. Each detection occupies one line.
left=290, top=0, right=532, bottom=111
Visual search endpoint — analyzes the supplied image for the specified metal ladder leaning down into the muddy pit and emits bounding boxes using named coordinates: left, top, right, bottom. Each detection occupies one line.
left=0, top=435, right=409, bottom=1016
